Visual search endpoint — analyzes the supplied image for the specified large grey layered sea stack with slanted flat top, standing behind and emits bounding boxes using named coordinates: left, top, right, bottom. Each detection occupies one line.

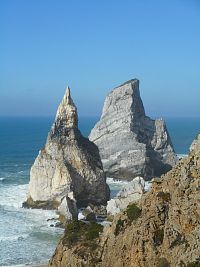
left=89, top=79, right=177, bottom=180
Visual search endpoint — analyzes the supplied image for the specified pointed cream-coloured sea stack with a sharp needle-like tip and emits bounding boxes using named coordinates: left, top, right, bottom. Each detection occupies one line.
left=24, top=87, right=109, bottom=208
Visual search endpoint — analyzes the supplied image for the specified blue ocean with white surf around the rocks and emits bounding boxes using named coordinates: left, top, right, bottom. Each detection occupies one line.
left=0, top=117, right=200, bottom=266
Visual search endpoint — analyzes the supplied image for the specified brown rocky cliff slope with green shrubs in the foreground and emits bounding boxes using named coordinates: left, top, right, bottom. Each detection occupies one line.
left=49, top=138, right=200, bottom=267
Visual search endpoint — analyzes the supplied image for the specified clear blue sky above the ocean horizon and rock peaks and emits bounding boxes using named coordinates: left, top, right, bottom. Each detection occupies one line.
left=0, top=0, right=200, bottom=117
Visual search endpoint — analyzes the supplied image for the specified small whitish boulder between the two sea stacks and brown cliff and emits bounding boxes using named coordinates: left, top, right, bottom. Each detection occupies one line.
left=107, top=177, right=145, bottom=216
